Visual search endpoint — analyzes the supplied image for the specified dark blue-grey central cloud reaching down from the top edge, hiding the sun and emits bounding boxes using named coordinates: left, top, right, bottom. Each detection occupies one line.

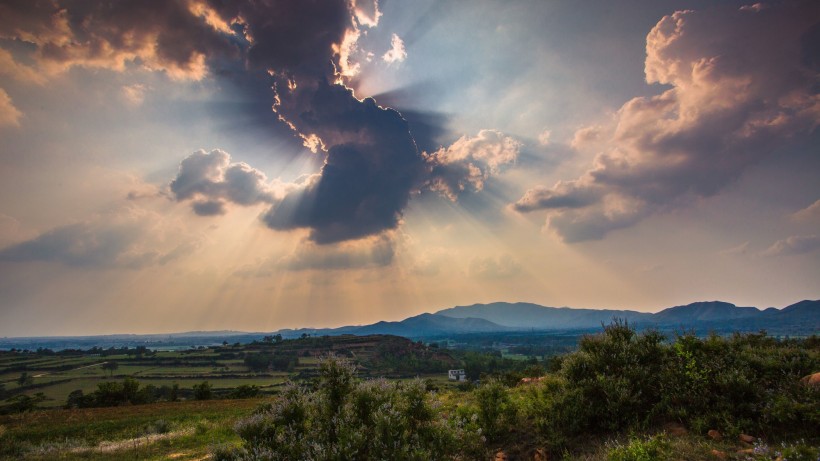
left=204, top=1, right=432, bottom=244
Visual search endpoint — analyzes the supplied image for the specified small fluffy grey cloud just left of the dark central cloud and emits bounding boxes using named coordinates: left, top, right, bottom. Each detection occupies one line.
left=170, top=149, right=284, bottom=216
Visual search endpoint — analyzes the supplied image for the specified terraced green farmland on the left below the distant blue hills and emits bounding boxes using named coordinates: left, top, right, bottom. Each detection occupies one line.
left=0, top=330, right=456, bottom=408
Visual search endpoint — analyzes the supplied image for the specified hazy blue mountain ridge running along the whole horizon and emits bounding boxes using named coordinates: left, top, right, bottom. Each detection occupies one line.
left=0, top=300, right=820, bottom=349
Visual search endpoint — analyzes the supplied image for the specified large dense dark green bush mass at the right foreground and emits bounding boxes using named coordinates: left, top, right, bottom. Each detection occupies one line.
left=524, top=321, right=820, bottom=450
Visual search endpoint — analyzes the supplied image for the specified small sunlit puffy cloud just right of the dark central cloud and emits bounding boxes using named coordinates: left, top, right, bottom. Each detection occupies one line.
left=426, top=130, right=522, bottom=200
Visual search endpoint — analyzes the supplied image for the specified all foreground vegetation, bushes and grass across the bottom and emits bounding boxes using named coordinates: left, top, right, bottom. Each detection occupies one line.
left=0, top=322, right=820, bottom=461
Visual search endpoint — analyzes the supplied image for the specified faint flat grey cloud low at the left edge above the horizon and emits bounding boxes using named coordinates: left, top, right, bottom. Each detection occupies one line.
left=0, top=209, right=197, bottom=269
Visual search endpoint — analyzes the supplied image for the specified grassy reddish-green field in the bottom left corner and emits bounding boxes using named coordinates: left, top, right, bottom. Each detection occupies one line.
left=0, top=399, right=264, bottom=460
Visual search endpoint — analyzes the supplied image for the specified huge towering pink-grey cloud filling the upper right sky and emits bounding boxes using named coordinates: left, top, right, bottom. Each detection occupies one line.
left=514, top=1, right=820, bottom=242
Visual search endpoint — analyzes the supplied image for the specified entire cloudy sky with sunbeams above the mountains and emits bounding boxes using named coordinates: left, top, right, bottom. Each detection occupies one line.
left=0, top=0, right=820, bottom=336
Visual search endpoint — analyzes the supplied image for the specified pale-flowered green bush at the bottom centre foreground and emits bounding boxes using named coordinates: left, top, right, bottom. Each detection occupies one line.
left=224, top=358, right=485, bottom=461
